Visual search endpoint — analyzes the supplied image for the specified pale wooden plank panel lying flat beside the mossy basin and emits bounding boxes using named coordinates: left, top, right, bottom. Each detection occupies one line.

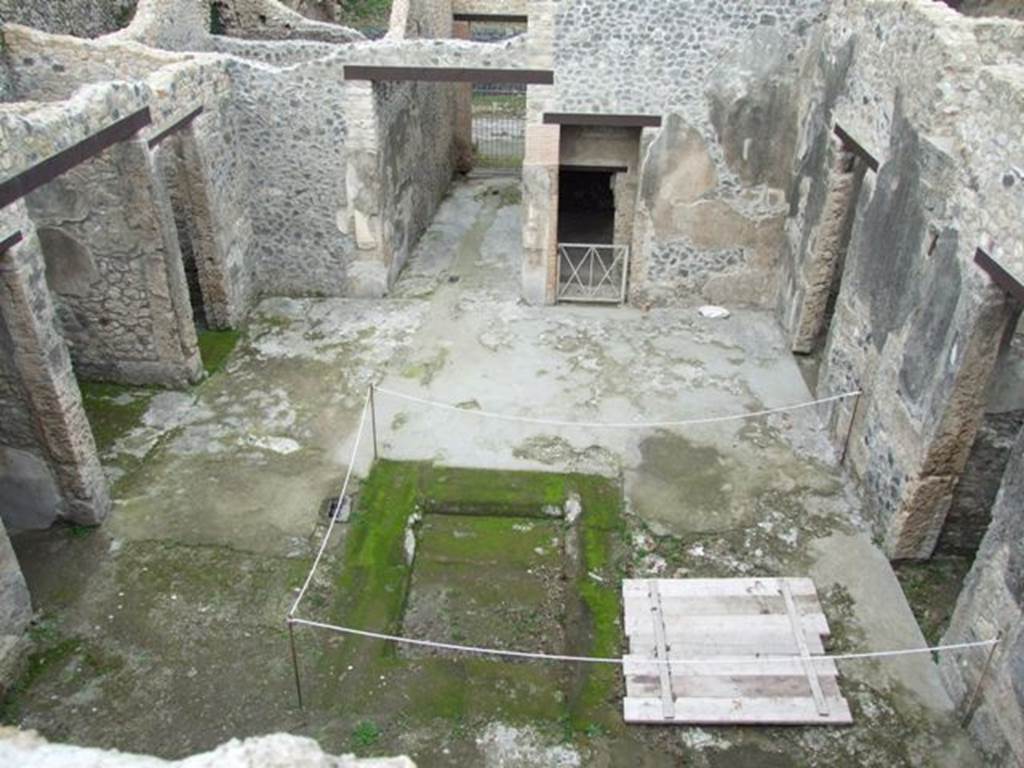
left=623, top=579, right=853, bottom=725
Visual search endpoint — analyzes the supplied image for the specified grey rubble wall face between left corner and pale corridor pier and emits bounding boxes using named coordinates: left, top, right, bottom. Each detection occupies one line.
left=219, top=58, right=354, bottom=296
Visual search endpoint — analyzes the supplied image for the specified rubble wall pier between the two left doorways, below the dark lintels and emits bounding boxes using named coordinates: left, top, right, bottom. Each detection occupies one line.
left=27, top=137, right=202, bottom=385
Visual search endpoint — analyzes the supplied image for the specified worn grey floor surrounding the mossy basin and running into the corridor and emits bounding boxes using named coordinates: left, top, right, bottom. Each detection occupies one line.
left=14, top=177, right=975, bottom=766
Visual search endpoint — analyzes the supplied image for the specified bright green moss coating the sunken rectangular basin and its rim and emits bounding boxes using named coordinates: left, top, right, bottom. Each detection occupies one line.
left=313, top=461, right=625, bottom=754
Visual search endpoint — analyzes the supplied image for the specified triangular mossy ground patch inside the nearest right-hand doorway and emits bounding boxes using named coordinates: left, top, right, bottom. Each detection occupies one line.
left=895, top=555, right=972, bottom=645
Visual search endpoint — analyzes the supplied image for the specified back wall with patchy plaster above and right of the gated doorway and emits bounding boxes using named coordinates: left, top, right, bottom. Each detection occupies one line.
left=530, top=0, right=825, bottom=304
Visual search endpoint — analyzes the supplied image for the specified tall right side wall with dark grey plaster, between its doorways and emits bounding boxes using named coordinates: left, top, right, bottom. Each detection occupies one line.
left=779, top=0, right=1024, bottom=558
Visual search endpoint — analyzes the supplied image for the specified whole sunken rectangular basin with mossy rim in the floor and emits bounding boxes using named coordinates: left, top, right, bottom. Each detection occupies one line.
left=303, top=461, right=624, bottom=759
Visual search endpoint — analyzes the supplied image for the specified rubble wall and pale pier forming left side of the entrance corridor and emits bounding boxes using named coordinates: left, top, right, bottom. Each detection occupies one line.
left=119, top=0, right=468, bottom=296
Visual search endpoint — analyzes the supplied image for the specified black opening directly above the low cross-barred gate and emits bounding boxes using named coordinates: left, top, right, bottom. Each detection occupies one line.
left=558, top=168, right=615, bottom=245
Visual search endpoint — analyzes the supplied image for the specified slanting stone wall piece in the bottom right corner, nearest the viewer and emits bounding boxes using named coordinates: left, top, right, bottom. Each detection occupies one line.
left=939, top=432, right=1024, bottom=765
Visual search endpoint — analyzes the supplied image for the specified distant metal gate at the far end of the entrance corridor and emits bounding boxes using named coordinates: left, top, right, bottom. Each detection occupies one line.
left=473, top=83, right=526, bottom=172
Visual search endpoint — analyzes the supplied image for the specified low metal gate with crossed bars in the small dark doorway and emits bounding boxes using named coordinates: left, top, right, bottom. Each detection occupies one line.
left=557, top=243, right=630, bottom=304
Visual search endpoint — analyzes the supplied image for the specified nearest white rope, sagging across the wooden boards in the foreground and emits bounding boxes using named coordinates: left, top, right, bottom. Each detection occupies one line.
left=292, top=617, right=999, bottom=667
